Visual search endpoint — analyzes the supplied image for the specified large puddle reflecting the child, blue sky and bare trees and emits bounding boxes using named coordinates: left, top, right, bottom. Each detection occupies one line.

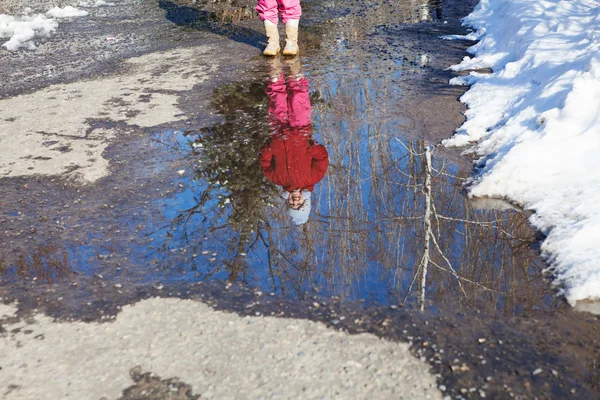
left=0, top=2, right=567, bottom=315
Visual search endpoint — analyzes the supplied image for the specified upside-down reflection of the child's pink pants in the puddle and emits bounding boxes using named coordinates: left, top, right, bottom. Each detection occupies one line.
left=266, top=74, right=310, bottom=128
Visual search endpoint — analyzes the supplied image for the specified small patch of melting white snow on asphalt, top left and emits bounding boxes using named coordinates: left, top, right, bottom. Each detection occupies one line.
left=0, top=7, right=88, bottom=51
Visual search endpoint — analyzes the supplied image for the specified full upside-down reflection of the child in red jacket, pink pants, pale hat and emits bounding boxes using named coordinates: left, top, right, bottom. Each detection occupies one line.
left=260, top=62, right=329, bottom=225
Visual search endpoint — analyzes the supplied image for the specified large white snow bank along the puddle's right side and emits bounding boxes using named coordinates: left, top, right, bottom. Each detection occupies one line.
left=444, top=0, right=600, bottom=304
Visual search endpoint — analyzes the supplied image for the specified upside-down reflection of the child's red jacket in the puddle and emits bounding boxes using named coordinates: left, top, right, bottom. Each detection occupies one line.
left=260, top=133, right=329, bottom=192
